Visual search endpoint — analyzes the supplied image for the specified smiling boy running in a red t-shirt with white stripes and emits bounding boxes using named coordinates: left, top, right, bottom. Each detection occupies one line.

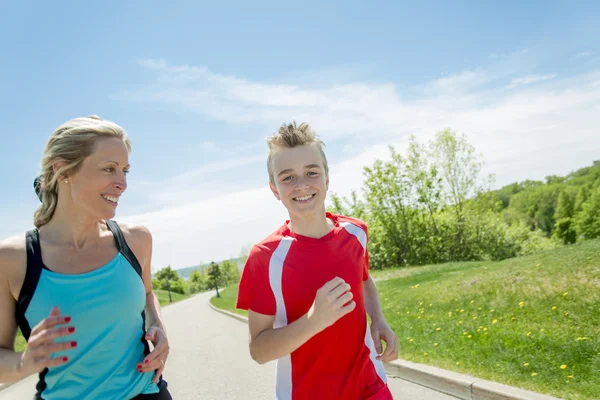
left=237, top=122, right=398, bottom=400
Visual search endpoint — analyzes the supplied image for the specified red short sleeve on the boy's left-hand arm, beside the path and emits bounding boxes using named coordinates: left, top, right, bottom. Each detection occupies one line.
left=236, top=246, right=276, bottom=315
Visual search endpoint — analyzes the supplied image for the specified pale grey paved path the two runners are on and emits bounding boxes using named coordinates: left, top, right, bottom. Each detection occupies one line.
left=0, top=293, right=456, bottom=400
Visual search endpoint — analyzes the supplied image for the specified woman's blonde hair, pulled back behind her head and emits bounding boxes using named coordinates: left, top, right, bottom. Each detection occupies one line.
left=33, top=115, right=131, bottom=228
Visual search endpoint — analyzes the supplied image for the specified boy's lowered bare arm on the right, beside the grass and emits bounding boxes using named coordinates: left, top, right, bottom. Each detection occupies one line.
left=363, top=275, right=398, bottom=363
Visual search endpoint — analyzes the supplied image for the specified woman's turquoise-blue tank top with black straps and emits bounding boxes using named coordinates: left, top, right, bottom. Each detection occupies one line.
left=16, top=221, right=159, bottom=400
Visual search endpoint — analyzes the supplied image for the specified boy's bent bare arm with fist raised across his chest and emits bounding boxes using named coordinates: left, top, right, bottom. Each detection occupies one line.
left=248, top=277, right=356, bottom=364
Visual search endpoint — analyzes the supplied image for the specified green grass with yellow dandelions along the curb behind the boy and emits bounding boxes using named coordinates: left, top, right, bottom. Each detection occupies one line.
left=213, top=240, right=600, bottom=400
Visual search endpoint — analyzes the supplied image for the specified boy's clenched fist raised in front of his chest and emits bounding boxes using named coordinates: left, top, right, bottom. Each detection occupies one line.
left=308, top=277, right=356, bottom=332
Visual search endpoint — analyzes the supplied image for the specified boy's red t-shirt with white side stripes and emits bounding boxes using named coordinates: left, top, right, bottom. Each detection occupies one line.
left=237, top=213, right=392, bottom=400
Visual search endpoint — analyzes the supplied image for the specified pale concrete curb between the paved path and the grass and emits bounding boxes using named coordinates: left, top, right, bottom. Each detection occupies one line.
left=208, top=301, right=560, bottom=400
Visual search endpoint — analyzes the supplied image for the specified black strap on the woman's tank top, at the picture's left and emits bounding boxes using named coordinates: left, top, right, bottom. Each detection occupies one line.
left=15, top=229, right=42, bottom=340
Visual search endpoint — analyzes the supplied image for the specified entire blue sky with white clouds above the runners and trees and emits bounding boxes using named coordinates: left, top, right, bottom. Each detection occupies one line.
left=0, top=1, right=600, bottom=268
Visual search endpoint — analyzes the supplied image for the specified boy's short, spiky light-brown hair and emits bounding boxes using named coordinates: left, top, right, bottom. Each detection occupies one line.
left=267, top=121, right=329, bottom=185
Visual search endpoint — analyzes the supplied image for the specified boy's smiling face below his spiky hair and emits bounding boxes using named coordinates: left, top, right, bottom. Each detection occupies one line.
left=269, top=144, right=329, bottom=217
